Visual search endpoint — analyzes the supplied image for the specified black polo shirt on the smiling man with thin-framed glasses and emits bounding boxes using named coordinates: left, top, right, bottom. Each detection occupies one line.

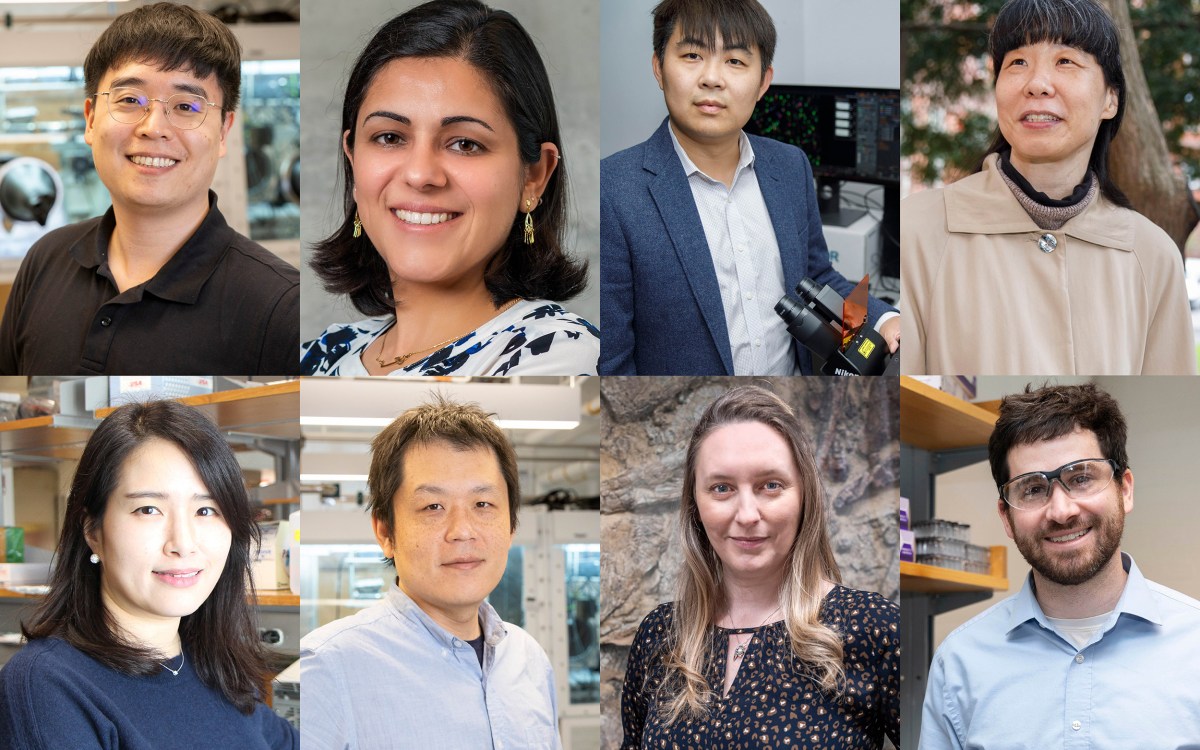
left=0, top=191, right=300, bottom=376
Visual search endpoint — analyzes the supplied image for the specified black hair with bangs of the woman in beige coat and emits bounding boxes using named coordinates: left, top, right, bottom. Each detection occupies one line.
left=977, top=0, right=1132, bottom=208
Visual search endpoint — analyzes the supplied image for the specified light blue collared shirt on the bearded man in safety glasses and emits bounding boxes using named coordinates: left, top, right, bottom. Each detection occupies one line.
left=920, top=554, right=1200, bottom=750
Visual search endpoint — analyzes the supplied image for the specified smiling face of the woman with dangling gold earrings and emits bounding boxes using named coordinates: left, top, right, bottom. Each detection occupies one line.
left=342, top=58, right=558, bottom=295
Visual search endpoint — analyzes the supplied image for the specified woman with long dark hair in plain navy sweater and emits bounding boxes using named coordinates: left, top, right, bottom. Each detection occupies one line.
left=0, top=401, right=299, bottom=750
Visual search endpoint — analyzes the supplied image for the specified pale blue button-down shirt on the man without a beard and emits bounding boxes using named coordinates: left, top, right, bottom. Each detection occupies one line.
left=300, top=583, right=562, bottom=750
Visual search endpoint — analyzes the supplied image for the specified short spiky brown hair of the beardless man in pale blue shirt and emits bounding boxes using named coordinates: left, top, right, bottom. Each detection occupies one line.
left=367, top=396, right=521, bottom=559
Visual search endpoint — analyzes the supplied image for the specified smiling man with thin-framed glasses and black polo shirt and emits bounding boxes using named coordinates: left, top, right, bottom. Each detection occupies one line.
left=0, top=2, right=300, bottom=374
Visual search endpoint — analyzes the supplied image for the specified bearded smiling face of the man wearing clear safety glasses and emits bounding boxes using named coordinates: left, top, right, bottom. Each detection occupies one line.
left=998, top=428, right=1133, bottom=586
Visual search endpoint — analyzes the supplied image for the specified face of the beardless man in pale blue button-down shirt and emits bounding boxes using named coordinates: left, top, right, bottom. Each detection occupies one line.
left=374, top=442, right=512, bottom=631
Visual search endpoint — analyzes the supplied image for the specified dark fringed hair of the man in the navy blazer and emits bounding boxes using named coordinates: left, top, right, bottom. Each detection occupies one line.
left=654, top=0, right=775, bottom=74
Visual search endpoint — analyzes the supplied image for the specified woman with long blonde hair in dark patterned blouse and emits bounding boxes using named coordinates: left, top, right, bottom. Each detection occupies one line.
left=622, top=385, right=900, bottom=750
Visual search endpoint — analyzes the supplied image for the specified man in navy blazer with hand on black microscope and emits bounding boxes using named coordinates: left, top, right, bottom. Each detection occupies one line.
left=599, top=0, right=900, bottom=376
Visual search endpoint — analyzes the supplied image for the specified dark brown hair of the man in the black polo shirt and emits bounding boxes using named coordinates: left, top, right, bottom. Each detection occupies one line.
left=83, top=2, right=241, bottom=115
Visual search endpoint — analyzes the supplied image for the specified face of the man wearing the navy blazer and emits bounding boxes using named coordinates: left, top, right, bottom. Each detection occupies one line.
left=650, top=25, right=773, bottom=152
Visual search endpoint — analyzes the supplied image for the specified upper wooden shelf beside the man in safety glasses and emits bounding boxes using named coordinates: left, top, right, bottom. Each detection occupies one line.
left=900, top=376, right=996, bottom=451
